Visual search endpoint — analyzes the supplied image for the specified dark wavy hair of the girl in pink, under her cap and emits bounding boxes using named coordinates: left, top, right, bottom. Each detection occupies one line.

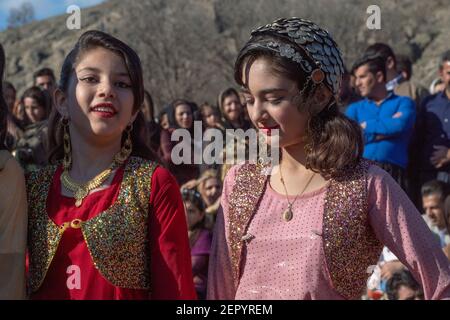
left=234, top=35, right=364, bottom=178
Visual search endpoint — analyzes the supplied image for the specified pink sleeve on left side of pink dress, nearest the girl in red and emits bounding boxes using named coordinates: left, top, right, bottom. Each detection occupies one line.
left=207, top=166, right=237, bottom=300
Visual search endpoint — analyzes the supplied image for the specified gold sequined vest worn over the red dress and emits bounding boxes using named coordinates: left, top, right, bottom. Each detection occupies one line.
left=27, top=157, right=156, bottom=293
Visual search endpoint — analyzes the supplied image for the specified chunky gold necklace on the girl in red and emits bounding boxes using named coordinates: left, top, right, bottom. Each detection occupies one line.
left=61, top=161, right=116, bottom=207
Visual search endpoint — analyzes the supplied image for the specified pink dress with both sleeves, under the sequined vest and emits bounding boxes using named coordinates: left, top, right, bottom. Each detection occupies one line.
left=208, top=165, right=450, bottom=300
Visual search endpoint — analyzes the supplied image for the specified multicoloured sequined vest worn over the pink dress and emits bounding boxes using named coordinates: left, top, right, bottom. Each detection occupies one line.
left=228, top=160, right=382, bottom=299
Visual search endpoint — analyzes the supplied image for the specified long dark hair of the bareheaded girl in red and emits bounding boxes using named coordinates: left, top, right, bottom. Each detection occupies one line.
left=48, top=30, right=160, bottom=163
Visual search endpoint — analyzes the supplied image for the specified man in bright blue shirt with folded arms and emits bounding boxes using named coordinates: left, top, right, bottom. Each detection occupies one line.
left=345, top=56, right=416, bottom=189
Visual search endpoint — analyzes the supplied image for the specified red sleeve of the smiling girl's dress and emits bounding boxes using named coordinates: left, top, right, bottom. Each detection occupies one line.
left=149, top=167, right=197, bottom=300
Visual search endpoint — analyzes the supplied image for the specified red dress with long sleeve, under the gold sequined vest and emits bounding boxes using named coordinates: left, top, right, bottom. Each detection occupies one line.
left=31, top=162, right=196, bottom=300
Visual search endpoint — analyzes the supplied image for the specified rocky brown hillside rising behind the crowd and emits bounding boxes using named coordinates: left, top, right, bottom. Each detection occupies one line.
left=0, top=0, right=450, bottom=112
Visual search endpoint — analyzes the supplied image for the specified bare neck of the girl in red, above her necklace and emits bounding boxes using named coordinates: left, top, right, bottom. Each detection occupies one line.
left=70, top=129, right=121, bottom=183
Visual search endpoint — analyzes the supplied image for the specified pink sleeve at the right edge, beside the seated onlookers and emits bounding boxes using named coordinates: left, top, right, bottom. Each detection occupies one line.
left=368, top=166, right=450, bottom=300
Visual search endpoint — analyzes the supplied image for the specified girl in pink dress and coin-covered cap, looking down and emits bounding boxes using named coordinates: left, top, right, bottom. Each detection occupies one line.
left=208, top=18, right=450, bottom=299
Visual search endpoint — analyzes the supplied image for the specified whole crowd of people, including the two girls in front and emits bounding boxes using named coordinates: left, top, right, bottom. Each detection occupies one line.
left=0, top=18, right=450, bottom=300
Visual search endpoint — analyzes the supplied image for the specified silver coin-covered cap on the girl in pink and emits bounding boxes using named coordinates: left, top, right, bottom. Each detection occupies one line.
left=251, top=18, right=344, bottom=95
